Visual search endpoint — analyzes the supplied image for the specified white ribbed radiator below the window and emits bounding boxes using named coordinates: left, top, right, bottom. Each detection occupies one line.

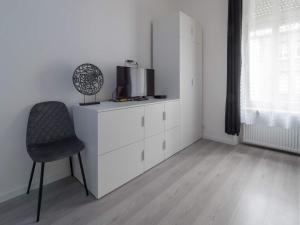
left=242, top=125, right=300, bottom=154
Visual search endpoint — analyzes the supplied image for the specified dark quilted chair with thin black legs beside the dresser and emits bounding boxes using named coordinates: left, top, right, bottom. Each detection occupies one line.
left=26, top=102, right=89, bottom=222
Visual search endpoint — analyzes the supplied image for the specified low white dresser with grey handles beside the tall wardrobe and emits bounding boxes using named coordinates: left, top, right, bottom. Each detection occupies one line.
left=73, top=99, right=181, bottom=198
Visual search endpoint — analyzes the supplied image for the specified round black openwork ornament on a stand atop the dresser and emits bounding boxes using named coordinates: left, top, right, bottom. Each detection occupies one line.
left=73, top=63, right=104, bottom=105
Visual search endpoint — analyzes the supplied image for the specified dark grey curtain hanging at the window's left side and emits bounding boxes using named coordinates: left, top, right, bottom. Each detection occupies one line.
left=225, top=0, right=243, bottom=135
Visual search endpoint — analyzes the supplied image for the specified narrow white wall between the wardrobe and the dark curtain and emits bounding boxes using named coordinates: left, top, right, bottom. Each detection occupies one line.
left=177, top=0, right=237, bottom=144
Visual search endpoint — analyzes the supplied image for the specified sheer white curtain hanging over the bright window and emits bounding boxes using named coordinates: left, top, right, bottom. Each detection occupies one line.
left=241, top=0, right=300, bottom=128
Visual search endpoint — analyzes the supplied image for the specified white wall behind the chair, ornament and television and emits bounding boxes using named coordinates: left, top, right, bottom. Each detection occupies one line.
left=0, top=0, right=174, bottom=202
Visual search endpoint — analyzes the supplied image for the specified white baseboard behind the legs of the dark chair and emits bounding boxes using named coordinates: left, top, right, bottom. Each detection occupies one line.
left=0, top=171, right=70, bottom=203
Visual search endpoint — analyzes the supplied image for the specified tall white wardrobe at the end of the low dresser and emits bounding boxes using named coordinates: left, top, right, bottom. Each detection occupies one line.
left=153, top=12, right=202, bottom=148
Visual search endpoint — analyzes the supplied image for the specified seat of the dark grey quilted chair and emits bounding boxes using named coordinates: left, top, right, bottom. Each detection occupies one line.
left=28, top=137, right=84, bottom=162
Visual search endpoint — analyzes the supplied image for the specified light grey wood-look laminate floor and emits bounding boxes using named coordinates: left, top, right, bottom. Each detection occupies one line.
left=0, top=140, right=300, bottom=225
